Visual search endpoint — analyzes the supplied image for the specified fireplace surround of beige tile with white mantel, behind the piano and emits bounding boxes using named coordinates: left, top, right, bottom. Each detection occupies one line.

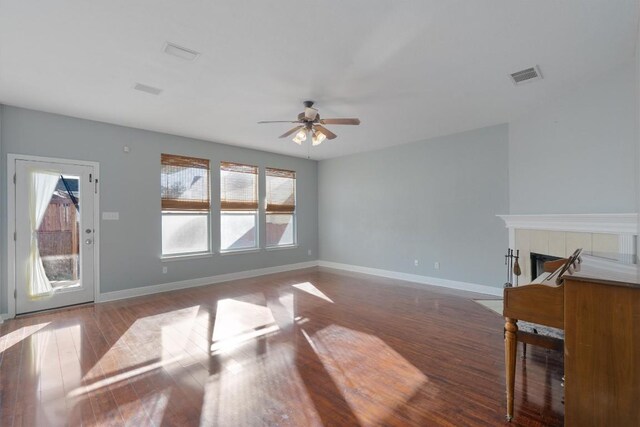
left=498, top=213, right=638, bottom=283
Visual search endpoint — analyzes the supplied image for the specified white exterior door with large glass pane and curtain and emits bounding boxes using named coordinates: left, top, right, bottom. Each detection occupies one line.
left=15, top=159, right=97, bottom=314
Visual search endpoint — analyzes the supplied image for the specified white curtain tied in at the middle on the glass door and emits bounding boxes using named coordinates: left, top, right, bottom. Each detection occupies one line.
left=27, top=170, right=60, bottom=299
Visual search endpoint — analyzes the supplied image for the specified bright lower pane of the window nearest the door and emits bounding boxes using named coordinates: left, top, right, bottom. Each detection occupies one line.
left=162, top=212, right=209, bottom=255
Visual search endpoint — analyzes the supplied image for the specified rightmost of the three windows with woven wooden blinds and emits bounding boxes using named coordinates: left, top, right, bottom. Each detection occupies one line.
left=267, top=168, right=296, bottom=247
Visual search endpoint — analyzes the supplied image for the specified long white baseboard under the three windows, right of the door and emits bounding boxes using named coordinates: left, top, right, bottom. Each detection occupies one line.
left=96, top=261, right=318, bottom=302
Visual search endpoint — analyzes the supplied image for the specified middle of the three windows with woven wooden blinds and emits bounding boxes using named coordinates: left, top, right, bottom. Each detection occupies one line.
left=220, top=162, right=258, bottom=252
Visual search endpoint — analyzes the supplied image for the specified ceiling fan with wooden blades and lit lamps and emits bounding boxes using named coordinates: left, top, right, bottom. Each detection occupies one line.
left=258, top=101, right=360, bottom=145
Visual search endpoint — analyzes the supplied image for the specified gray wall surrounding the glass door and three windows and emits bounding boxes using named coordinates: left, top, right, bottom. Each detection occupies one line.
left=0, top=106, right=318, bottom=312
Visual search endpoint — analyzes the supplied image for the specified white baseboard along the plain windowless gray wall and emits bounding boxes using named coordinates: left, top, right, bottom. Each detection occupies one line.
left=318, top=260, right=503, bottom=297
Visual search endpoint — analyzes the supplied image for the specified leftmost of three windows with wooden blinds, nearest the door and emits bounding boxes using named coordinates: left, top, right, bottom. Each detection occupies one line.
left=160, top=153, right=211, bottom=256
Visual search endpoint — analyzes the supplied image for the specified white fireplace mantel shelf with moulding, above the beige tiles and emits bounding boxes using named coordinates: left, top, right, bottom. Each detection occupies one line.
left=497, top=213, right=638, bottom=254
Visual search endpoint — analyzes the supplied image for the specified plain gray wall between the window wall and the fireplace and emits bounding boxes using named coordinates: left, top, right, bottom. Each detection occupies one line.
left=318, top=125, right=509, bottom=287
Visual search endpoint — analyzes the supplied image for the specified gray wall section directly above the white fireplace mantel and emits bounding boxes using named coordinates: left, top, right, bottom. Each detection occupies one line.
left=509, top=62, right=638, bottom=214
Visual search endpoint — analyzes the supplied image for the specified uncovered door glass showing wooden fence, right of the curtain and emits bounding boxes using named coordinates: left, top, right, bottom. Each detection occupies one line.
left=37, top=175, right=82, bottom=291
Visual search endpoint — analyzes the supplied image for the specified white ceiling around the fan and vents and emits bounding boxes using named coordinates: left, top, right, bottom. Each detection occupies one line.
left=0, top=0, right=638, bottom=159
